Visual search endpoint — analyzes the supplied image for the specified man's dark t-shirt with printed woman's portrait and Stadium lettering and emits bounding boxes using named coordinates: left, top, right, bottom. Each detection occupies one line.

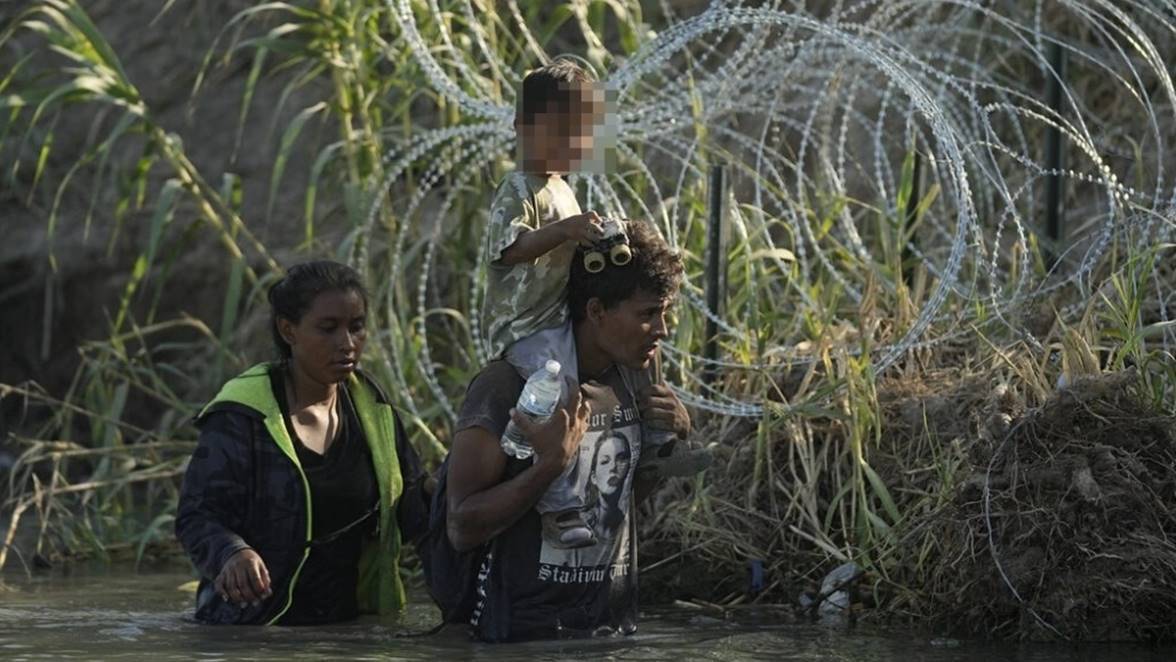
left=457, top=361, right=641, bottom=641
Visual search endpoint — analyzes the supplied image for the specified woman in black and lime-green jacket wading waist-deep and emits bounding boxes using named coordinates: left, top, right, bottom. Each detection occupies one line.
left=175, top=262, right=428, bottom=624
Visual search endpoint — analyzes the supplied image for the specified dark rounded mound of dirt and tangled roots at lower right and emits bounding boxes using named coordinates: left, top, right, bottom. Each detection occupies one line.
left=943, top=370, right=1176, bottom=640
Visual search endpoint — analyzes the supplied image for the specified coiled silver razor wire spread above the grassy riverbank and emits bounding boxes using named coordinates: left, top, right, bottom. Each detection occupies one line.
left=366, top=0, right=1176, bottom=420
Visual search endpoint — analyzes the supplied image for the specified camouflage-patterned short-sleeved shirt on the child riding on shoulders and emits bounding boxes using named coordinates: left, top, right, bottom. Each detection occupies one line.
left=482, top=172, right=580, bottom=359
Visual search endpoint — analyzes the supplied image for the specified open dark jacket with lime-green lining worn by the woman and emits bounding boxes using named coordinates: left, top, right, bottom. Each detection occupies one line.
left=175, top=363, right=428, bottom=624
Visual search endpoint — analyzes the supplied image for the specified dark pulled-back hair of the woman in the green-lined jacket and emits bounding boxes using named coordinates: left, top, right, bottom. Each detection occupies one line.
left=268, top=260, right=367, bottom=359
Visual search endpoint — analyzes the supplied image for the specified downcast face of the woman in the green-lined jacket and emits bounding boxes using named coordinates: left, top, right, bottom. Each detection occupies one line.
left=278, top=289, right=367, bottom=383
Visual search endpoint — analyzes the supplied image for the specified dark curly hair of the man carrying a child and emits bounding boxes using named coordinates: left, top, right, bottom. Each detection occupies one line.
left=568, top=221, right=683, bottom=321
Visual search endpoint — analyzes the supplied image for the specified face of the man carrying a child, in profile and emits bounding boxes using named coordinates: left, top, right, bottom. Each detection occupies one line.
left=599, top=288, right=675, bottom=370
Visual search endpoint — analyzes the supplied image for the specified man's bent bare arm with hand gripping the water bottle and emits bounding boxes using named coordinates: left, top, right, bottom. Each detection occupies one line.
left=446, top=385, right=588, bottom=551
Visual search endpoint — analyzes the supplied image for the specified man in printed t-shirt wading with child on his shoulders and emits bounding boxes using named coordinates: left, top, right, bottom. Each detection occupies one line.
left=446, top=222, right=690, bottom=641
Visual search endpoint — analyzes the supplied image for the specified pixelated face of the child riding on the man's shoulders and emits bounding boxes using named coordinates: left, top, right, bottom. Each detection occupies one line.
left=517, top=83, right=604, bottom=173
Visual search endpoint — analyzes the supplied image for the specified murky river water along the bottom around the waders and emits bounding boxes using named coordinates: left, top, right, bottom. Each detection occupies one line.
left=0, top=568, right=1176, bottom=662
